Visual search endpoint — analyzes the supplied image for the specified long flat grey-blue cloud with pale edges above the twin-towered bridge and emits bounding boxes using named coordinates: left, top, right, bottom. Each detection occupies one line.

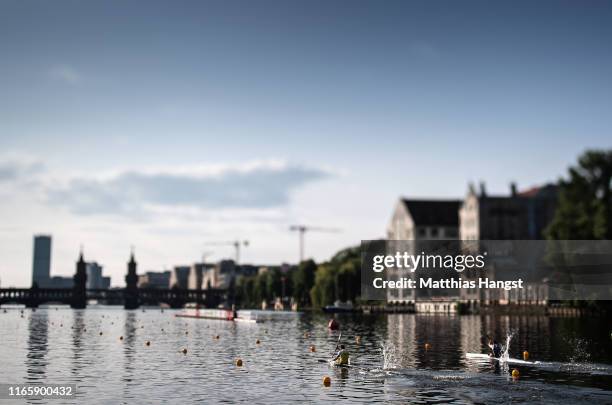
left=45, top=161, right=332, bottom=218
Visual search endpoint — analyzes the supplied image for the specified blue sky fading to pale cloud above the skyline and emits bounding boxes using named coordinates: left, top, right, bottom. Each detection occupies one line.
left=0, top=0, right=612, bottom=286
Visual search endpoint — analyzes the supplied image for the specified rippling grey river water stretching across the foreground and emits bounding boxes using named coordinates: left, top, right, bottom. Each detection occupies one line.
left=0, top=307, right=612, bottom=404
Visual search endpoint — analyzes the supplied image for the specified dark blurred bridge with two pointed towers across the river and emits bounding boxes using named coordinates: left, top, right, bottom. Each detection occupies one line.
left=0, top=253, right=231, bottom=309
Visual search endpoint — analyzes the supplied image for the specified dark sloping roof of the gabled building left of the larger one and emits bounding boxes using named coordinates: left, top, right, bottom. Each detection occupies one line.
left=402, top=198, right=461, bottom=227
